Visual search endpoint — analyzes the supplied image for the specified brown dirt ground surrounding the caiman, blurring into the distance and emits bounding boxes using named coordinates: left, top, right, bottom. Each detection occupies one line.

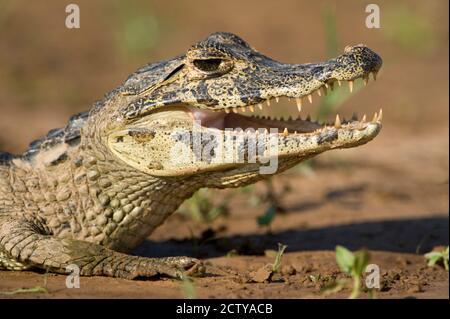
left=0, top=1, right=449, bottom=298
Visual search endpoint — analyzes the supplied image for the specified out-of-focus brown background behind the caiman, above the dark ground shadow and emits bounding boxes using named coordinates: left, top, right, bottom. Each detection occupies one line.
left=0, top=0, right=449, bottom=249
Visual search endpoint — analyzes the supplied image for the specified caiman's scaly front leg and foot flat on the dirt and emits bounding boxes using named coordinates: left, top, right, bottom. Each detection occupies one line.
left=0, top=217, right=201, bottom=279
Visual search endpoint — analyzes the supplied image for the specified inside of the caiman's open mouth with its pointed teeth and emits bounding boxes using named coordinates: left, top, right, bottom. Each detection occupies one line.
left=188, top=72, right=383, bottom=136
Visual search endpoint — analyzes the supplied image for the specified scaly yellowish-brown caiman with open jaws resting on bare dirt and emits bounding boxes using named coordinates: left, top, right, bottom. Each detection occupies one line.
left=0, top=33, right=381, bottom=279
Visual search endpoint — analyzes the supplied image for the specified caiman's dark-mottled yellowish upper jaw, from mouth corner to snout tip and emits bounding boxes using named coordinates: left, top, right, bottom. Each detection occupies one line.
left=122, top=45, right=382, bottom=119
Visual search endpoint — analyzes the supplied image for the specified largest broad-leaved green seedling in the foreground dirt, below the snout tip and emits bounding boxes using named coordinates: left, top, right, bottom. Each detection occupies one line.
left=323, top=246, right=373, bottom=299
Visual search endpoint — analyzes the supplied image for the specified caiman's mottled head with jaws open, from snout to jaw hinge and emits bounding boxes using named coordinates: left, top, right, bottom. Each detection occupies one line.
left=90, top=33, right=382, bottom=187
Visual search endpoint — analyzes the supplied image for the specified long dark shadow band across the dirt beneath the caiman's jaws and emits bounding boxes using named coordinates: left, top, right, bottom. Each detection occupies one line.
left=134, top=217, right=449, bottom=258
